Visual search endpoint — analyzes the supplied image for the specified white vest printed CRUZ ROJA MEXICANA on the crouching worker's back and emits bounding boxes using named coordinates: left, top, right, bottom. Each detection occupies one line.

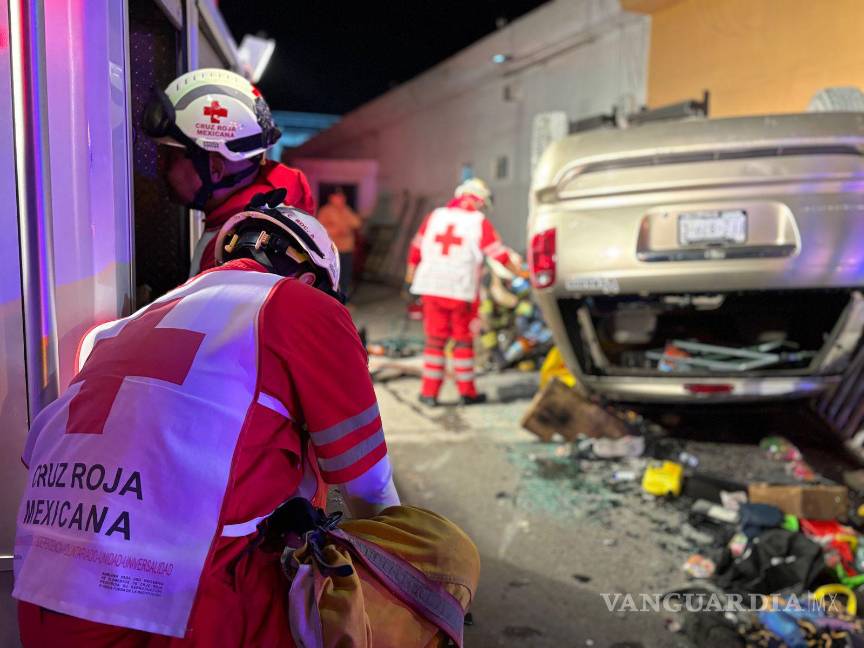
left=13, top=270, right=281, bottom=637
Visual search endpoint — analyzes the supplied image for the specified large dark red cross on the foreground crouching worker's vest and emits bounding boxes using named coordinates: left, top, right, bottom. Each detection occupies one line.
left=66, top=299, right=204, bottom=434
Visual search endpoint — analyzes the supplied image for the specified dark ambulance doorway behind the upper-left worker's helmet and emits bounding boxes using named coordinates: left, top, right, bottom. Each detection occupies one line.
left=129, top=2, right=189, bottom=307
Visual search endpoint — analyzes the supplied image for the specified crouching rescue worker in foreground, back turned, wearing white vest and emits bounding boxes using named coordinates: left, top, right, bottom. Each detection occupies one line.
left=13, top=186, right=399, bottom=648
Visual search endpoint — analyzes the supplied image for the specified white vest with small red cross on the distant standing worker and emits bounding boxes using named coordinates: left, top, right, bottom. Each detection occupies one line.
left=411, top=207, right=485, bottom=302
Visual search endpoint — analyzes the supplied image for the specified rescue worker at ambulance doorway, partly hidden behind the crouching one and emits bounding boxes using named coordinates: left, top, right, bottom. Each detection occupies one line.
left=142, top=68, right=315, bottom=277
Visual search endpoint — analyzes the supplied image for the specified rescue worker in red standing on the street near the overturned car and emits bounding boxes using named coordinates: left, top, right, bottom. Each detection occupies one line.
left=405, top=178, right=518, bottom=406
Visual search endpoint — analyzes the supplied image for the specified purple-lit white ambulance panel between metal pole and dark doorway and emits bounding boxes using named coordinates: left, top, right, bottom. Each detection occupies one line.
left=45, top=0, right=132, bottom=390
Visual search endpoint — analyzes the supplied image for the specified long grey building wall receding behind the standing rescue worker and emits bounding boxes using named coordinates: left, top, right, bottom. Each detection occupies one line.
left=290, top=0, right=649, bottom=258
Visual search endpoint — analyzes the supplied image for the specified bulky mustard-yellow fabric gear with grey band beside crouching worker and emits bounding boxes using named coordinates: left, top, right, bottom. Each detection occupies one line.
left=290, top=506, right=480, bottom=648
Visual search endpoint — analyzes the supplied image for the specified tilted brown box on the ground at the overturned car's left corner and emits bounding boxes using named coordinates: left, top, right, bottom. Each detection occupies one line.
left=522, top=378, right=630, bottom=441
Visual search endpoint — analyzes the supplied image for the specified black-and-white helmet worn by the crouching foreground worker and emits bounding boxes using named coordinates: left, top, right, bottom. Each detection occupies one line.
left=215, top=189, right=340, bottom=296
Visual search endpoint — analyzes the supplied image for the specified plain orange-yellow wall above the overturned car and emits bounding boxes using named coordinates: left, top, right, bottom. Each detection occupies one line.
left=622, top=0, right=864, bottom=117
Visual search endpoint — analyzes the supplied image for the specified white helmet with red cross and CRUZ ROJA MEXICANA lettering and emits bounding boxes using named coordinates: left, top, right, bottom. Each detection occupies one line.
left=144, top=68, right=281, bottom=161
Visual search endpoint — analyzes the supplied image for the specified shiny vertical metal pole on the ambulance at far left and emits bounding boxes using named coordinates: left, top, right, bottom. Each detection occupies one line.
left=9, top=0, right=60, bottom=422
